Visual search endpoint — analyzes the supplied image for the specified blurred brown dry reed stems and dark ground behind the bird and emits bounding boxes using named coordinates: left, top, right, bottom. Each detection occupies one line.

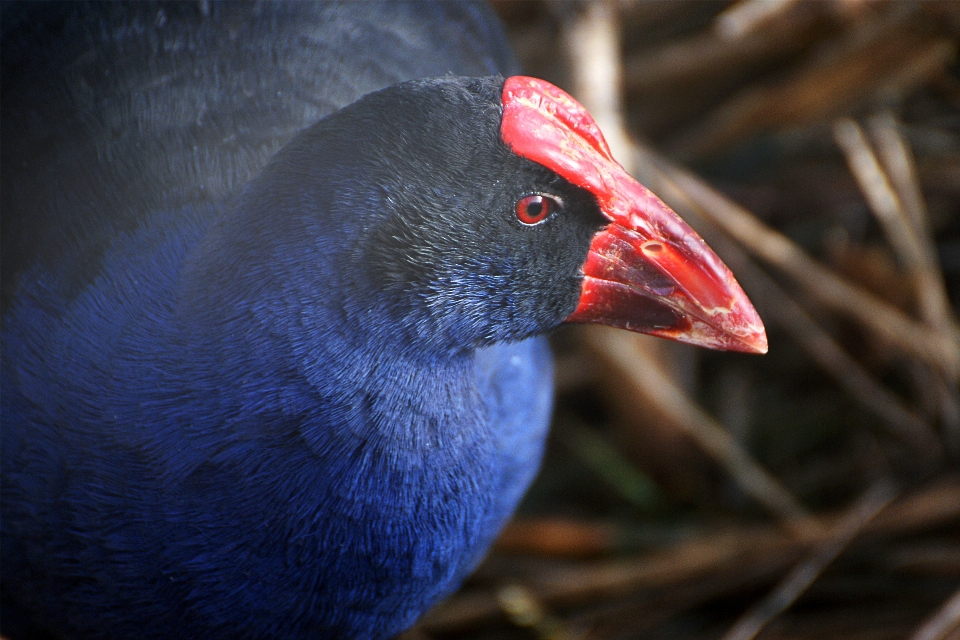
left=404, top=0, right=960, bottom=640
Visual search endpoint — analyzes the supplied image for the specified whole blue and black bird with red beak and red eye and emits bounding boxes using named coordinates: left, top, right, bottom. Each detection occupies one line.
left=0, top=1, right=766, bottom=640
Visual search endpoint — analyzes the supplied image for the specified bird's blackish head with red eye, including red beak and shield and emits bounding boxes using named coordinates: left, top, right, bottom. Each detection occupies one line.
left=244, top=76, right=766, bottom=353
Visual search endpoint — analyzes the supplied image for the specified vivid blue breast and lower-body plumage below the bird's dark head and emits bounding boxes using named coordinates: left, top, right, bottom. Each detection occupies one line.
left=3, top=204, right=550, bottom=638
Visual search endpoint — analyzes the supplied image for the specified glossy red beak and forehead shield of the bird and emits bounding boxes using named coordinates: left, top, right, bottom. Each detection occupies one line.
left=500, top=76, right=767, bottom=353
